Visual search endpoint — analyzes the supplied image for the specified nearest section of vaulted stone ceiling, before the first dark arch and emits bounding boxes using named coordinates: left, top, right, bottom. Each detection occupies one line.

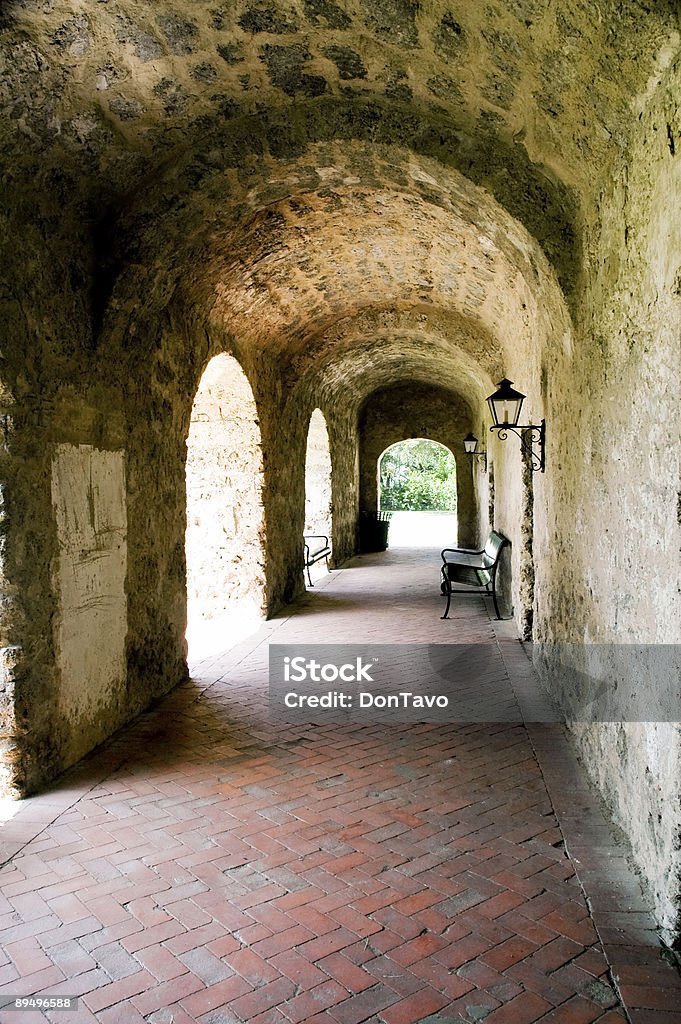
left=1, top=0, right=676, bottom=203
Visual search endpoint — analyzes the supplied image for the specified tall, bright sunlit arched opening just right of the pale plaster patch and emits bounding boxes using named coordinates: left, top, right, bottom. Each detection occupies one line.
left=185, top=354, right=265, bottom=659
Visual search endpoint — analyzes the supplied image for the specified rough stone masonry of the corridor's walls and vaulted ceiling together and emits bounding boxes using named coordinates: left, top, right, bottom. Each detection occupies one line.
left=0, top=0, right=681, bottom=940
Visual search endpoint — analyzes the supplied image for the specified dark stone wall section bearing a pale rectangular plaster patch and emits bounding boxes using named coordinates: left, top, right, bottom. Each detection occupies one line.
left=0, top=207, right=127, bottom=795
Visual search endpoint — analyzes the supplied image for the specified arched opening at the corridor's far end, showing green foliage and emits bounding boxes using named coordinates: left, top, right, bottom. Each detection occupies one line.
left=378, top=437, right=457, bottom=547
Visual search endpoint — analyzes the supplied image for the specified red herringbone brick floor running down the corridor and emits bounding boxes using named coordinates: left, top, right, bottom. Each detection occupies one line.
left=0, top=551, right=681, bottom=1024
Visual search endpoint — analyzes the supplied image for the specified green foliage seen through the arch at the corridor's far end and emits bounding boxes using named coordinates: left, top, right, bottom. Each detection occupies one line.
left=379, top=438, right=457, bottom=512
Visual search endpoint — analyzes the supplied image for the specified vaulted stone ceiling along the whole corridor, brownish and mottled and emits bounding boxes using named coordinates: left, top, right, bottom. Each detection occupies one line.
left=0, top=0, right=678, bottom=407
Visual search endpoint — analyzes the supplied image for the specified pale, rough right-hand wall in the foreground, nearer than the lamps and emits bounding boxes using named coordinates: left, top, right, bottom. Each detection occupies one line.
left=536, top=62, right=681, bottom=938
